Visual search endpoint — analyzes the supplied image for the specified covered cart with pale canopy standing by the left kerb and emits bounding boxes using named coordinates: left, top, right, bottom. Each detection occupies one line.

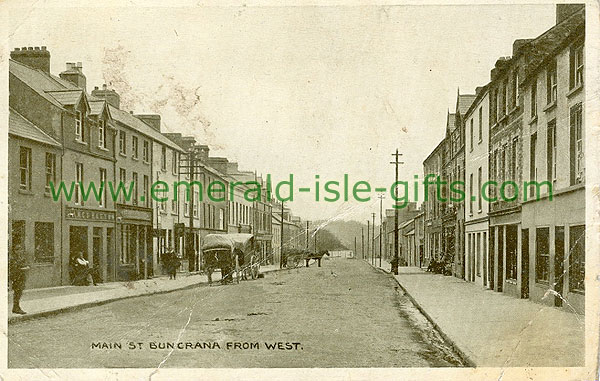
left=202, top=233, right=260, bottom=283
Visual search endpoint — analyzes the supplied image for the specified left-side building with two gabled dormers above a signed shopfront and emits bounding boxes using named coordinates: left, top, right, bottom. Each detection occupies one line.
left=9, top=47, right=116, bottom=286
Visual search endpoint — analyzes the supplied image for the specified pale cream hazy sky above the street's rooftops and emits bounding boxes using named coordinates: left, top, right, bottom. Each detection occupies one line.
left=9, top=5, right=555, bottom=221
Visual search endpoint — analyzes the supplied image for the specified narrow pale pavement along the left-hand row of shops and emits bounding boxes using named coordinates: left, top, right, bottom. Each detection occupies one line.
left=8, top=265, right=279, bottom=324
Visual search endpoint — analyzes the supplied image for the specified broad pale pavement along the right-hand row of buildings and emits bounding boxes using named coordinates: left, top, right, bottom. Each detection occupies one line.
left=368, top=261, right=585, bottom=367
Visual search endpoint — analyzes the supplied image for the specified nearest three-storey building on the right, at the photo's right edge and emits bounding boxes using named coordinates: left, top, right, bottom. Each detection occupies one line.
left=517, top=5, right=585, bottom=313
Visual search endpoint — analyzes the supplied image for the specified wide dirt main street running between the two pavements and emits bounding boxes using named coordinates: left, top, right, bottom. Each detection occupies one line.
left=8, top=258, right=460, bottom=368
